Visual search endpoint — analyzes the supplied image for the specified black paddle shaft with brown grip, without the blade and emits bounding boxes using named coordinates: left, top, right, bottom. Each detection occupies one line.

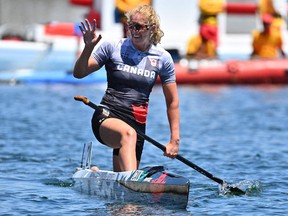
left=74, top=96, right=225, bottom=185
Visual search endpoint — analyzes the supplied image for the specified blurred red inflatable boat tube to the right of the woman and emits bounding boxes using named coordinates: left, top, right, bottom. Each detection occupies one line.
left=166, top=59, right=288, bottom=85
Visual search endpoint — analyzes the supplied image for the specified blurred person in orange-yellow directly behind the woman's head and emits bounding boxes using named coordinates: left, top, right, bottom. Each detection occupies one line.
left=115, top=0, right=152, bottom=37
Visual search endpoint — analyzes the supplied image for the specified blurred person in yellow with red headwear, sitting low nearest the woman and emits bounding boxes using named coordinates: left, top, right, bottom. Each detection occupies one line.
left=186, top=29, right=216, bottom=60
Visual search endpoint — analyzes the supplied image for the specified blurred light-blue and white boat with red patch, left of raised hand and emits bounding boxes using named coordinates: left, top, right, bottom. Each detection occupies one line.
left=0, top=23, right=80, bottom=73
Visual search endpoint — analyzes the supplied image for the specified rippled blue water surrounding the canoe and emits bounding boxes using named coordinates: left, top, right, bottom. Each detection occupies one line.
left=0, top=84, right=288, bottom=215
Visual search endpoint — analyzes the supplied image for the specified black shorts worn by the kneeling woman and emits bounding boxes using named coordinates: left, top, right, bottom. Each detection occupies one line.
left=91, top=108, right=145, bottom=161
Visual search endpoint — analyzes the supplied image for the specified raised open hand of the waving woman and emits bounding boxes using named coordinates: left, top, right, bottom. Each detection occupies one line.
left=79, top=19, right=102, bottom=47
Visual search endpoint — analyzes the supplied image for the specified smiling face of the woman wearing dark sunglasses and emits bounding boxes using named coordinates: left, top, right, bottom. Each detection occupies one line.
left=128, top=13, right=154, bottom=49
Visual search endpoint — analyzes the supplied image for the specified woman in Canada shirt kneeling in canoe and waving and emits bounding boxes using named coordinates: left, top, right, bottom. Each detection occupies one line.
left=74, top=5, right=180, bottom=172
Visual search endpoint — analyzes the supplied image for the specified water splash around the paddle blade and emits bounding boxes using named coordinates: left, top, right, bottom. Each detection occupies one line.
left=219, top=180, right=263, bottom=196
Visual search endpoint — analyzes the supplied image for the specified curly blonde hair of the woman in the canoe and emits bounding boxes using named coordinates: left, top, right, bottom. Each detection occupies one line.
left=125, top=5, right=164, bottom=45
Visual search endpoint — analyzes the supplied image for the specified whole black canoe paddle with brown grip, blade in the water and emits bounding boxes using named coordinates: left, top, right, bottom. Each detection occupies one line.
left=74, top=96, right=245, bottom=195
